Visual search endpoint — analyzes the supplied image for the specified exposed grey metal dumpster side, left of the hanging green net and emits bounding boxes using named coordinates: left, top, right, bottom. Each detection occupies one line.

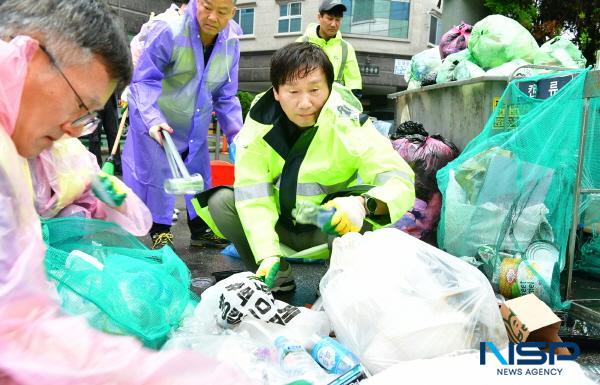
left=388, top=76, right=508, bottom=150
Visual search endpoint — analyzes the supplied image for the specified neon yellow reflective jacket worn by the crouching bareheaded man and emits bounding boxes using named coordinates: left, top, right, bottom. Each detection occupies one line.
left=234, top=83, right=415, bottom=261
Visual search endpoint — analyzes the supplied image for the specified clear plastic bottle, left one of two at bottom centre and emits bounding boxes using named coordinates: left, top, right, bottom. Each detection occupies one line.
left=275, top=336, right=327, bottom=382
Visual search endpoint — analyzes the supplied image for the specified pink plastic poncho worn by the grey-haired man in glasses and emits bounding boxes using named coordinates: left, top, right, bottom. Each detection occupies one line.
left=0, top=37, right=253, bottom=385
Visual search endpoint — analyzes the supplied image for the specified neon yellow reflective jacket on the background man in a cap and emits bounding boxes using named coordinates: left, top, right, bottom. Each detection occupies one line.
left=296, top=23, right=362, bottom=90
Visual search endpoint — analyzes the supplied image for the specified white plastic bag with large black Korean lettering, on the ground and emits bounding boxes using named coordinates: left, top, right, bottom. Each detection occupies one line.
left=163, top=272, right=335, bottom=385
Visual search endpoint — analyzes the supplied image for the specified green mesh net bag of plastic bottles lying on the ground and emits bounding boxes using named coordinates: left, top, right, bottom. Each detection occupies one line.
left=42, top=217, right=197, bottom=348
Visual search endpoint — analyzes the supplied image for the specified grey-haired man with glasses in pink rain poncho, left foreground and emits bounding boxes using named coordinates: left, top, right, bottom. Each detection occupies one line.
left=0, top=0, right=251, bottom=385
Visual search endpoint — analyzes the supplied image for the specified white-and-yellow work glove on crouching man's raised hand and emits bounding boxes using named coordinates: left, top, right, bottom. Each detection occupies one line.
left=323, top=196, right=367, bottom=235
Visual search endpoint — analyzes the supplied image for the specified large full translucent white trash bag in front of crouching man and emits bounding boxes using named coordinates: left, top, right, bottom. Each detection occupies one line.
left=320, top=229, right=508, bottom=374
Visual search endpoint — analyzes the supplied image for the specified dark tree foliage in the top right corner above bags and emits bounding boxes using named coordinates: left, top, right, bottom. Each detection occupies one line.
left=484, top=0, right=600, bottom=64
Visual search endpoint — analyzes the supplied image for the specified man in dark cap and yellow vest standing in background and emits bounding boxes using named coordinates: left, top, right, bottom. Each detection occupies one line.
left=296, top=0, right=362, bottom=99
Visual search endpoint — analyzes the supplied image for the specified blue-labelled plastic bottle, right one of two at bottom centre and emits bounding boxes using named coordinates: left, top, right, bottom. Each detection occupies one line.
left=309, top=334, right=360, bottom=374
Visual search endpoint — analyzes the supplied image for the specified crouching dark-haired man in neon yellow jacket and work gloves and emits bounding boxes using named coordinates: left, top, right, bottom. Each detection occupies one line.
left=195, top=43, right=415, bottom=291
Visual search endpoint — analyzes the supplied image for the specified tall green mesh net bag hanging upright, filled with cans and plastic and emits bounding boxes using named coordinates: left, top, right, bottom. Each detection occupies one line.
left=437, top=70, right=588, bottom=308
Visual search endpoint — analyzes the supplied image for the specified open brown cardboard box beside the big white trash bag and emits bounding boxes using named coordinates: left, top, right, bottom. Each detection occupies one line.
left=500, top=294, right=570, bottom=354
